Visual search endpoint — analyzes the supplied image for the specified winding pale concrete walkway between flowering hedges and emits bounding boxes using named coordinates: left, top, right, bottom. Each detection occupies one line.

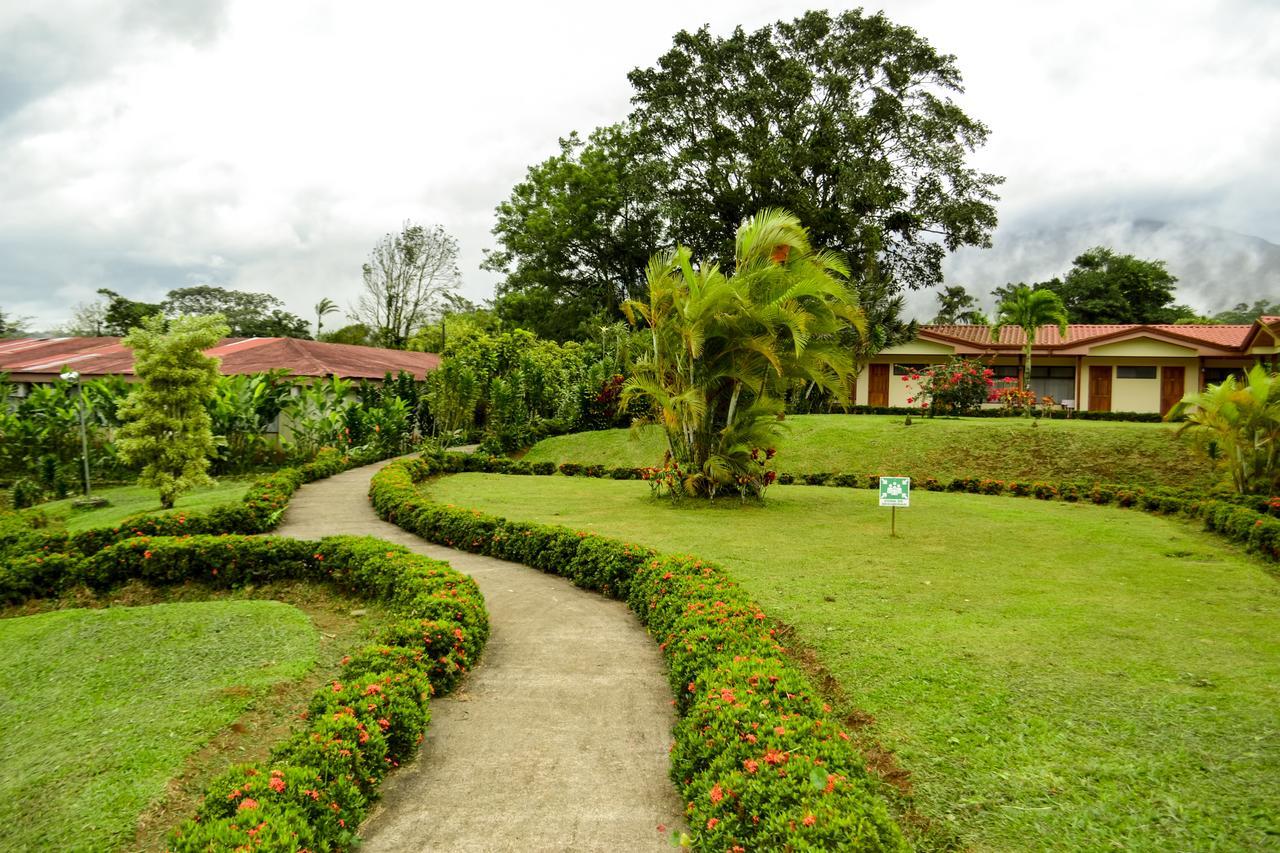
left=276, top=465, right=684, bottom=853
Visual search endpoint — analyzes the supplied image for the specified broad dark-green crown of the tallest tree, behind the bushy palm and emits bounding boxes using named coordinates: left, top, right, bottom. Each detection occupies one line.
left=489, top=10, right=1001, bottom=337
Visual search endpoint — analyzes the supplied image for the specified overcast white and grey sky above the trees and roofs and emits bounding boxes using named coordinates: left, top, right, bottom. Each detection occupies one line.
left=0, top=0, right=1280, bottom=328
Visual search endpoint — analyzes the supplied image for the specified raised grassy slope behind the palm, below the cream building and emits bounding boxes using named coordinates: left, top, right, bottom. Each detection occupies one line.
left=525, top=415, right=1211, bottom=487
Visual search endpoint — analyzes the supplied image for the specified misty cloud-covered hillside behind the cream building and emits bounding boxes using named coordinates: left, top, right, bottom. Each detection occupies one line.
left=936, top=219, right=1280, bottom=316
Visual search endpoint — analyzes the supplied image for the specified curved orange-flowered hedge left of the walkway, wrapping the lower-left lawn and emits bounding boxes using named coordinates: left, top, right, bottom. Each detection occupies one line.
left=3, top=534, right=489, bottom=853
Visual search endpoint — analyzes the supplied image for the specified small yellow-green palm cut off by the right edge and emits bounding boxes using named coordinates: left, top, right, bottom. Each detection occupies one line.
left=1165, top=365, right=1280, bottom=494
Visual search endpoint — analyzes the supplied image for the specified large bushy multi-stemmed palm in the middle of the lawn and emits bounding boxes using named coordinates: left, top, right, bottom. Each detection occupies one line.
left=622, top=210, right=865, bottom=497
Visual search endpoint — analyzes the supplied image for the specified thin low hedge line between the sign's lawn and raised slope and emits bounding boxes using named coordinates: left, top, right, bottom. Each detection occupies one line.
left=436, top=453, right=1280, bottom=562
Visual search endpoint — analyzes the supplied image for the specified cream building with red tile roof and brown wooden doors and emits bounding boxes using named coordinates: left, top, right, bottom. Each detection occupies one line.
left=856, top=316, right=1280, bottom=412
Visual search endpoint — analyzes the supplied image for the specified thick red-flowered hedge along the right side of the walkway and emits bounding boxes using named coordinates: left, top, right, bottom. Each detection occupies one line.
left=370, top=459, right=906, bottom=850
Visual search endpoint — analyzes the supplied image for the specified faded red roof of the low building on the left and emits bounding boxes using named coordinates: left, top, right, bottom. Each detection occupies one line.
left=0, top=338, right=440, bottom=379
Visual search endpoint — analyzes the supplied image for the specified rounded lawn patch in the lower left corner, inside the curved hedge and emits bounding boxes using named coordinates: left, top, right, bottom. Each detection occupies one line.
left=0, top=601, right=319, bottom=850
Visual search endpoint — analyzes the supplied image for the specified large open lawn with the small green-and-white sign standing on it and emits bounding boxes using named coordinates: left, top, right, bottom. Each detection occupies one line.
left=424, top=473, right=1280, bottom=850
